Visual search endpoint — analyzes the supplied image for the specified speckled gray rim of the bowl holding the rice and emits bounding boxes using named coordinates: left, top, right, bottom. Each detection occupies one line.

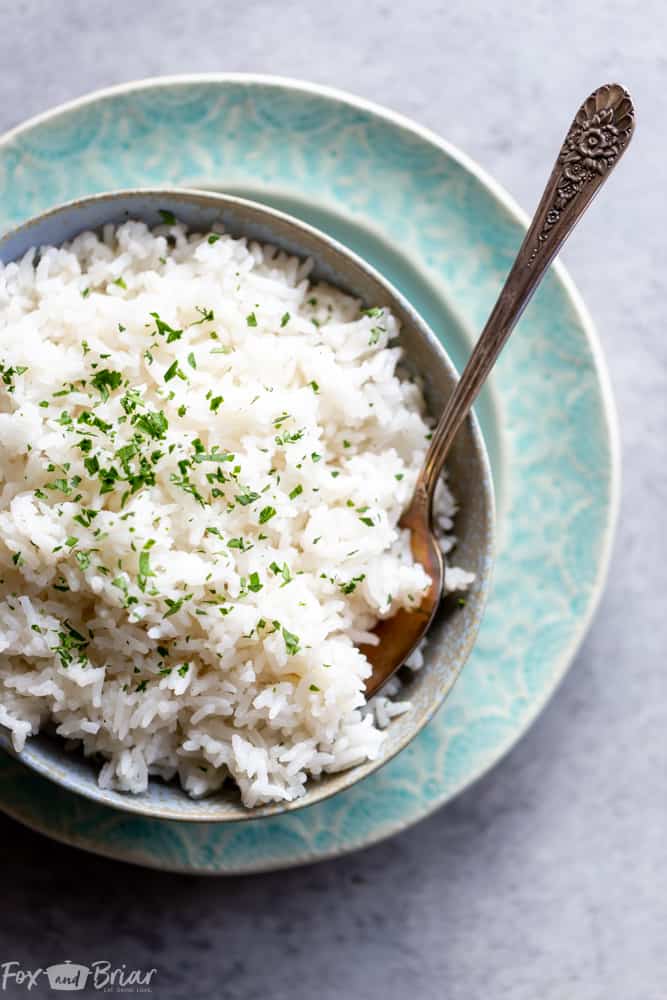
left=0, top=187, right=495, bottom=823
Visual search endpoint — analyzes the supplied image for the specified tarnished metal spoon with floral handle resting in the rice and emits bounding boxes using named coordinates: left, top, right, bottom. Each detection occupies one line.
left=361, top=83, right=635, bottom=697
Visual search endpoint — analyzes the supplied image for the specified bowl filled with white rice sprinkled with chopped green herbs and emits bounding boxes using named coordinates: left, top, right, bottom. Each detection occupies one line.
left=0, top=191, right=493, bottom=821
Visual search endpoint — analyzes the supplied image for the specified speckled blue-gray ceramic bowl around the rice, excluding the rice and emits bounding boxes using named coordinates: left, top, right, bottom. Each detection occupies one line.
left=0, top=190, right=494, bottom=822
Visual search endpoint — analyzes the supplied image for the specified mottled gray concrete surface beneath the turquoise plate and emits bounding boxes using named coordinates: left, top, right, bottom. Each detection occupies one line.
left=0, top=0, right=667, bottom=1000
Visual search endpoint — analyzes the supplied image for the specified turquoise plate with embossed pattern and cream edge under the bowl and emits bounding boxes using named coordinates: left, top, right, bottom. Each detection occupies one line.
left=0, top=75, right=619, bottom=874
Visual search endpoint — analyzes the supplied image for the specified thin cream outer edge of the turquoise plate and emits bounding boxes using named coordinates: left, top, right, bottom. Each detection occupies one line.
left=0, top=72, right=621, bottom=875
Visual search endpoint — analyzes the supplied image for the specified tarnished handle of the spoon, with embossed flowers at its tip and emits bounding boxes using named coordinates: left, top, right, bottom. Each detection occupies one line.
left=413, top=83, right=635, bottom=508
